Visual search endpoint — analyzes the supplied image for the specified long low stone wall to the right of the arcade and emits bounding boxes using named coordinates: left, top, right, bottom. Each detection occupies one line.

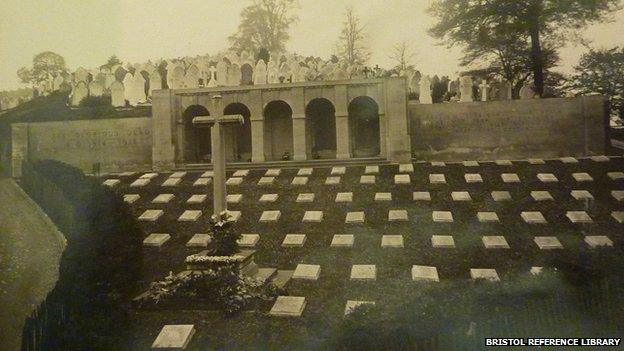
left=408, top=96, right=606, bottom=161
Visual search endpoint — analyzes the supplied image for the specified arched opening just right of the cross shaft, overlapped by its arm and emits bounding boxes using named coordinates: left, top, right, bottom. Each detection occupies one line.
left=223, top=102, right=251, bottom=162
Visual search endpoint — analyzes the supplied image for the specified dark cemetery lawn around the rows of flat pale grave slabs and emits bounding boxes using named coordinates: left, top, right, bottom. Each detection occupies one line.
left=103, top=158, right=624, bottom=350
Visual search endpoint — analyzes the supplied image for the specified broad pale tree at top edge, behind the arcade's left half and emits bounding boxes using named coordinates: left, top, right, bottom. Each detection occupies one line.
left=228, top=0, right=298, bottom=53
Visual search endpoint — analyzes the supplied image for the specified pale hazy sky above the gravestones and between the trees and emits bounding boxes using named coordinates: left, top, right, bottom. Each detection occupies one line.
left=0, top=0, right=624, bottom=90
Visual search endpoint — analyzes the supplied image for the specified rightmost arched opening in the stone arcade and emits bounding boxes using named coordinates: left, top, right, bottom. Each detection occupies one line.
left=349, top=96, right=381, bottom=157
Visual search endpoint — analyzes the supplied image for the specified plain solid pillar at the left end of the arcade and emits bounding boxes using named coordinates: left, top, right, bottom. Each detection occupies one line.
left=152, top=90, right=175, bottom=171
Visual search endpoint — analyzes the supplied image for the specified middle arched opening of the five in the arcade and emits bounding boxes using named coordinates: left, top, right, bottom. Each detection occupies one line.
left=263, top=100, right=293, bottom=160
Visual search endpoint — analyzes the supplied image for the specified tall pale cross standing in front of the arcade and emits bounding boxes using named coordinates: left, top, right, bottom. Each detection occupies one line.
left=193, top=95, right=245, bottom=220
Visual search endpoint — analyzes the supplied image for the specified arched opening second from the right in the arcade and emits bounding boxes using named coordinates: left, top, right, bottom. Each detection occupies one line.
left=305, top=98, right=336, bottom=159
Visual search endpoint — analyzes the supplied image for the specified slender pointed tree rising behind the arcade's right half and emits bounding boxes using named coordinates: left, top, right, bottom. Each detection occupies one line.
left=336, top=7, right=370, bottom=66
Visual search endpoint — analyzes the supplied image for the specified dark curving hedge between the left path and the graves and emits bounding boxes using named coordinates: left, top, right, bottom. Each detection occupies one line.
left=21, top=160, right=143, bottom=350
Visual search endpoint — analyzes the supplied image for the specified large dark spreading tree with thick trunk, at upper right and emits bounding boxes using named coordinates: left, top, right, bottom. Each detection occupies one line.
left=429, top=0, right=621, bottom=96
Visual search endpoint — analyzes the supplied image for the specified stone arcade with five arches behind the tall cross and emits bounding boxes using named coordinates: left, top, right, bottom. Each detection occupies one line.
left=152, top=78, right=411, bottom=169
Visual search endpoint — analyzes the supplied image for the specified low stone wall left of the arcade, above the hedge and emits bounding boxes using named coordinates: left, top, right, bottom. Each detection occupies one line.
left=12, top=117, right=152, bottom=176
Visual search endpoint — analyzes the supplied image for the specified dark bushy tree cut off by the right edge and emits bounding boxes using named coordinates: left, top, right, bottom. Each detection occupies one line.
left=569, top=47, right=624, bottom=117
